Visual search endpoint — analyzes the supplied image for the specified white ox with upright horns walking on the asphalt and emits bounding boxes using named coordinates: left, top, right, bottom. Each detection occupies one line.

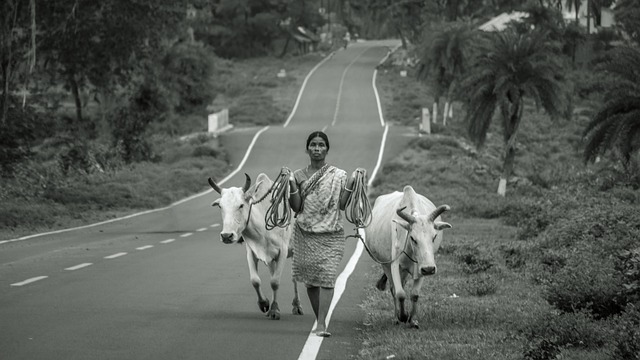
left=209, top=173, right=302, bottom=320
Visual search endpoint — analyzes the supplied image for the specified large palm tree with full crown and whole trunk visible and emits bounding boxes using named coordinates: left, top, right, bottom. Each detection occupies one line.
left=461, top=28, right=566, bottom=196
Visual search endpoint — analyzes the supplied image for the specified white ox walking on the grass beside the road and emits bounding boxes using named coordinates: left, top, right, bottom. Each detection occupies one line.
left=365, top=185, right=451, bottom=328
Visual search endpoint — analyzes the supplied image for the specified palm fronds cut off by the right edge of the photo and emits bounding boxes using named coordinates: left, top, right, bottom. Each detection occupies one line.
left=583, top=46, right=640, bottom=168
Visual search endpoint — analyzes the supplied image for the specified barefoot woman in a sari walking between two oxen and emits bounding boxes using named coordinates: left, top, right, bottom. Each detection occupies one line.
left=289, top=131, right=354, bottom=337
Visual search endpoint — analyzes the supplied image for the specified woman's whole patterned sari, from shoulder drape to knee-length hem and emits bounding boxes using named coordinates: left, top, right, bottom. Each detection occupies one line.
left=292, top=165, right=347, bottom=288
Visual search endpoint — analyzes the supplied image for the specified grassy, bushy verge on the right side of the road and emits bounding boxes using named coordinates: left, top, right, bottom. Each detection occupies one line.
left=356, top=63, right=640, bottom=360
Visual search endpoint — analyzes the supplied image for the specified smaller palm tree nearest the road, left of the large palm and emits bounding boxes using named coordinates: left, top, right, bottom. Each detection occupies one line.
left=417, top=24, right=472, bottom=125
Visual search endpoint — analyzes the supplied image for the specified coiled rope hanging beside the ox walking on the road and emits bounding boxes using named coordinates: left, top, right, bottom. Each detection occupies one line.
left=261, top=167, right=291, bottom=230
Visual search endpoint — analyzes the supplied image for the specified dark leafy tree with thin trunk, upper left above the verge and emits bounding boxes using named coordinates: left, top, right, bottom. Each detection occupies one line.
left=39, top=0, right=187, bottom=129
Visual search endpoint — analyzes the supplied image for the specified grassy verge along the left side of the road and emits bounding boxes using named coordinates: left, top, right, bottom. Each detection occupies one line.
left=0, top=54, right=322, bottom=240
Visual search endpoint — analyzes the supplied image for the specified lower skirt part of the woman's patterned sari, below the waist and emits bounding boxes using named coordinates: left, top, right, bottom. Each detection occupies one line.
left=292, top=225, right=345, bottom=288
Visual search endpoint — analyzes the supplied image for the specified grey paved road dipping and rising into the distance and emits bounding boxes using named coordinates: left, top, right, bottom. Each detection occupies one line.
left=0, top=43, right=408, bottom=360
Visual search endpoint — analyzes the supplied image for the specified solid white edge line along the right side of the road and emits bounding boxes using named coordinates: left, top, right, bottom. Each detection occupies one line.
left=298, top=54, right=389, bottom=360
